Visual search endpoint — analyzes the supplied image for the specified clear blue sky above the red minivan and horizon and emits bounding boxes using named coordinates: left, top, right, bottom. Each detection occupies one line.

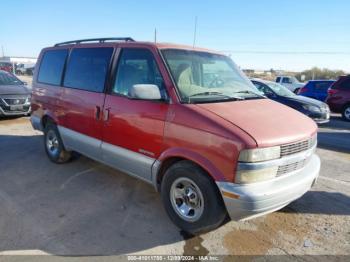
left=0, top=0, right=350, bottom=72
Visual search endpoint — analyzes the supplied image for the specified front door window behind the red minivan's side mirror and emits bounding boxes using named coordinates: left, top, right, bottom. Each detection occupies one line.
left=112, top=48, right=166, bottom=99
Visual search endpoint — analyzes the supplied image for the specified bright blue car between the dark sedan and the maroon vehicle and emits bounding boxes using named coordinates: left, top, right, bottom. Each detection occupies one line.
left=298, top=80, right=335, bottom=102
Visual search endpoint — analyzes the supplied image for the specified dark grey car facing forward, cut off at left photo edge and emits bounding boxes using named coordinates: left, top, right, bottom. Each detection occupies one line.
left=0, top=70, right=31, bottom=117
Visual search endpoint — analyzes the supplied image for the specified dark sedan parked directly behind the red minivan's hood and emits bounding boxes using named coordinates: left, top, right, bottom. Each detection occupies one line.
left=252, top=79, right=330, bottom=124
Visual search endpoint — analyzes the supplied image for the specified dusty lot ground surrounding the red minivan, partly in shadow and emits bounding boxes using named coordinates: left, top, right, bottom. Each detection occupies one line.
left=0, top=117, right=350, bottom=260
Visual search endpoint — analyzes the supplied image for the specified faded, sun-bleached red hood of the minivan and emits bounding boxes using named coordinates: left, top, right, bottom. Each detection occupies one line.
left=197, top=99, right=317, bottom=147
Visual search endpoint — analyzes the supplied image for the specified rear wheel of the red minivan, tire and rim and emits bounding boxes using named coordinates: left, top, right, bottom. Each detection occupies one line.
left=44, top=122, right=72, bottom=164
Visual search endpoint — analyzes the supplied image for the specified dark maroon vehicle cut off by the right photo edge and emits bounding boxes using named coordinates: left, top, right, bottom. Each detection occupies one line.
left=326, top=75, right=350, bottom=121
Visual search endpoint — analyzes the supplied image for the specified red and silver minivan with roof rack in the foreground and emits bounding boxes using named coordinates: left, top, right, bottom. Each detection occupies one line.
left=31, top=38, right=320, bottom=234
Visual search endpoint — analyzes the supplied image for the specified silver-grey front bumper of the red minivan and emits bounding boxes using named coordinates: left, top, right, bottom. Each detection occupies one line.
left=217, top=154, right=321, bottom=220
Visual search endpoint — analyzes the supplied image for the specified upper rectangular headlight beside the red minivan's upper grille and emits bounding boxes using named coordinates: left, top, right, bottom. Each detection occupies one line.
left=238, top=146, right=281, bottom=162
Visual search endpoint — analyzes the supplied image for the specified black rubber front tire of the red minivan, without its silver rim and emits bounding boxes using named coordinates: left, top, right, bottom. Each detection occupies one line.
left=161, top=160, right=227, bottom=235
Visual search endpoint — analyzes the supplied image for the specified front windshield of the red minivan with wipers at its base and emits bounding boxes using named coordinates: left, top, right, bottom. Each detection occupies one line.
left=162, top=49, right=264, bottom=103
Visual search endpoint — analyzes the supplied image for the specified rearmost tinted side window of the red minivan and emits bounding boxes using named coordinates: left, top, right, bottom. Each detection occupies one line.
left=38, top=49, right=68, bottom=85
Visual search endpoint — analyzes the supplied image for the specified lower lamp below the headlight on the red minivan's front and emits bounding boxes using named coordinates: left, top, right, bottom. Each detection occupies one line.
left=235, top=166, right=278, bottom=184
